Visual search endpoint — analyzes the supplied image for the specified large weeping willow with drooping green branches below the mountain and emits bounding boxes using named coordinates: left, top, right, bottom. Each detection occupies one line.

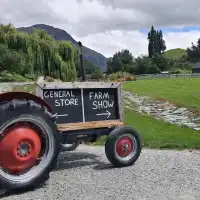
left=0, top=24, right=77, bottom=81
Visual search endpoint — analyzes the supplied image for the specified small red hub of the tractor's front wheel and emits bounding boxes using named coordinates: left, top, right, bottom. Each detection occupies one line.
left=116, top=136, right=134, bottom=157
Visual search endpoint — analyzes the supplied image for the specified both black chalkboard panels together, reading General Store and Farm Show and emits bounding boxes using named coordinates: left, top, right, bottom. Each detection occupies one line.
left=38, top=85, right=120, bottom=124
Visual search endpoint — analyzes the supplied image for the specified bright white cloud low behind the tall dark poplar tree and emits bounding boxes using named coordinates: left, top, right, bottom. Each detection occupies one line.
left=75, top=30, right=200, bottom=57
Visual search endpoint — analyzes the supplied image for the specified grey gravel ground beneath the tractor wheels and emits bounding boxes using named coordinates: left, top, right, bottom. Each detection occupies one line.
left=2, top=145, right=200, bottom=200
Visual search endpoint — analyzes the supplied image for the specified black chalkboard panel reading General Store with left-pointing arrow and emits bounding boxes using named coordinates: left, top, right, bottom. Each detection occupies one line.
left=43, top=89, right=83, bottom=124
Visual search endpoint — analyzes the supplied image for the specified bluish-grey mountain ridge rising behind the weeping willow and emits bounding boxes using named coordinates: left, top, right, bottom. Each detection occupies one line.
left=17, top=24, right=107, bottom=71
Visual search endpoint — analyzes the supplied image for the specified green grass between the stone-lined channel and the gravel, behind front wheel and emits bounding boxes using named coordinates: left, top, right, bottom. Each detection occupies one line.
left=94, top=109, right=200, bottom=149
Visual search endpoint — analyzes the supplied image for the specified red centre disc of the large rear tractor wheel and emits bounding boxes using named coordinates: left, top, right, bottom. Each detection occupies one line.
left=0, top=123, right=41, bottom=173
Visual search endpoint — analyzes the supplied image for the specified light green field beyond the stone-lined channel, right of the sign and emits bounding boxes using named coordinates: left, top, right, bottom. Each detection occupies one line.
left=123, top=78, right=200, bottom=111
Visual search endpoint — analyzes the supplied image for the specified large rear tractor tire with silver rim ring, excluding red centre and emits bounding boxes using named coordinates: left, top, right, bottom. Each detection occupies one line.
left=0, top=100, right=60, bottom=195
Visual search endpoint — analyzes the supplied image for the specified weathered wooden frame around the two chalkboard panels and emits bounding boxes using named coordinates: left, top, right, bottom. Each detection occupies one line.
left=36, top=82, right=124, bottom=131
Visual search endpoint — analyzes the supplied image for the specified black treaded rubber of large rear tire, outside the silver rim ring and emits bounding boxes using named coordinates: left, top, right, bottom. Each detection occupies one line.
left=0, top=99, right=61, bottom=195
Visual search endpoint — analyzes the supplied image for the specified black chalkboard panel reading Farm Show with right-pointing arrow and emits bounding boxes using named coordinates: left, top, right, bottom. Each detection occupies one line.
left=83, top=88, right=119, bottom=122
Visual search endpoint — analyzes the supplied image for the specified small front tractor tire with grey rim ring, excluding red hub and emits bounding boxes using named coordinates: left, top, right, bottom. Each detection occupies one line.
left=105, top=127, right=142, bottom=167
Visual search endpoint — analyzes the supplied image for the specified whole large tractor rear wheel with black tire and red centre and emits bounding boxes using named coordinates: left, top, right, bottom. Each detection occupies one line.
left=0, top=100, right=60, bottom=195
